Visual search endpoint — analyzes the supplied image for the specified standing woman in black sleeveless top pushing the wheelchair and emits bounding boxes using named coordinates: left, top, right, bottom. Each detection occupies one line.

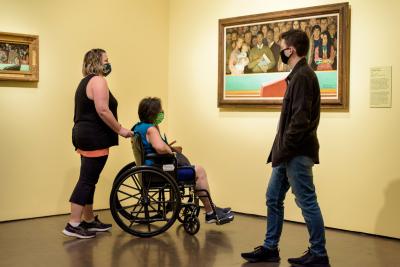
left=62, top=49, right=132, bottom=238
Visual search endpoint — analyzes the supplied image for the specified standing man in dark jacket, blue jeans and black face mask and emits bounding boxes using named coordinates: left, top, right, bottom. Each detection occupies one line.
left=242, top=30, right=330, bottom=267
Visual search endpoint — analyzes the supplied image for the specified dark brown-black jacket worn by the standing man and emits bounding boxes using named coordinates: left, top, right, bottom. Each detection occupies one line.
left=267, top=58, right=321, bottom=167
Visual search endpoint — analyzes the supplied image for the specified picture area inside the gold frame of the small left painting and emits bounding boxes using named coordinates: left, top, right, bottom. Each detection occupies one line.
left=0, top=42, right=29, bottom=70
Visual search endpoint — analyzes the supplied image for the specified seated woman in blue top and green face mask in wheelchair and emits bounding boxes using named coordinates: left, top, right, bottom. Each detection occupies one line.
left=132, top=97, right=234, bottom=223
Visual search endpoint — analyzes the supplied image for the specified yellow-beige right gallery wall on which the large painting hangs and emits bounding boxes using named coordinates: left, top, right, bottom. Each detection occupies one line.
left=167, top=0, right=400, bottom=238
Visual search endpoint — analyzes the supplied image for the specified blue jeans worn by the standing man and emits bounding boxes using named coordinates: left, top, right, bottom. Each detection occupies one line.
left=264, top=156, right=327, bottom=256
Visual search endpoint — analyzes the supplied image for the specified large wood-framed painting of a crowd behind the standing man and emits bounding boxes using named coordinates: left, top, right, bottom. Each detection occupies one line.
left=218, top=3, right=350, bottom=111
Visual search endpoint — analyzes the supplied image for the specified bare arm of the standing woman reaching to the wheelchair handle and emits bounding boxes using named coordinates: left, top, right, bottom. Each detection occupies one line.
left=86, top=76, right=132, bottom=137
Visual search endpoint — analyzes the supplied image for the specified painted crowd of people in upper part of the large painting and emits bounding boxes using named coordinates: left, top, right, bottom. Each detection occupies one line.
left=225, top=15, right=338, bottom=75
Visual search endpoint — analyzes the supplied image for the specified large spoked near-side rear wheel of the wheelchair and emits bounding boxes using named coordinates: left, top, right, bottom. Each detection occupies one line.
left=110, top=166, right=181, bottom=237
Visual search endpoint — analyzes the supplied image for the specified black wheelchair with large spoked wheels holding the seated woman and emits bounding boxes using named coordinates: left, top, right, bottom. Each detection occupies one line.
left=110, top=133, right=229, bottom=237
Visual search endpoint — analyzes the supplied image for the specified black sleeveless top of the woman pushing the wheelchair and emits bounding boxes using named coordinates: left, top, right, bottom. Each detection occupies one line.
left=72, top=74, right=118, bottom=151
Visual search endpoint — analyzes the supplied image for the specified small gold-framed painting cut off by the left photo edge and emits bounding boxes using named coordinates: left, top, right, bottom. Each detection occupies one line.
left=0, top=32, right=39, bottom=82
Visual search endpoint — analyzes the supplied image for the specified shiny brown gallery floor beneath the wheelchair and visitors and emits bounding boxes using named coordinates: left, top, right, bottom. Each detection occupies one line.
left=0, top=211, right=400, bottom=267
